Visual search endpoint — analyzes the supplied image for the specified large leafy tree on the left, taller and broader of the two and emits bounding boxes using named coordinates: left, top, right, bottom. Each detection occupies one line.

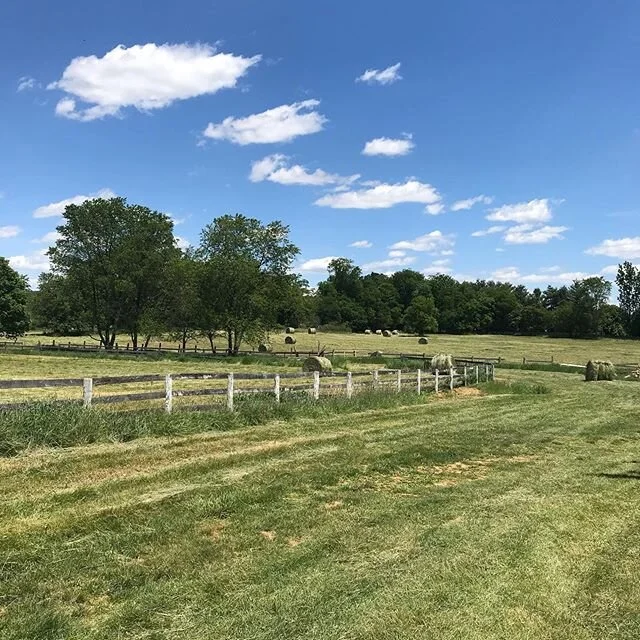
left=49, top=198, right=177, bottom=349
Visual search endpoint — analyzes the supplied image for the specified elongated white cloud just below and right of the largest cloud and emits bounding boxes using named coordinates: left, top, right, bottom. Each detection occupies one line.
left=202, top=100, right=327, bottom=145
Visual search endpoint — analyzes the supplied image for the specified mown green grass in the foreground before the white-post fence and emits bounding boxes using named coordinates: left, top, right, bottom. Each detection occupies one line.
left=0, top=372, right=640, bottom=640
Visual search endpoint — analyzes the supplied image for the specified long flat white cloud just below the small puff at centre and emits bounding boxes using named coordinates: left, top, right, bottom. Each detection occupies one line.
left=315, top=180, right=440, bottom=209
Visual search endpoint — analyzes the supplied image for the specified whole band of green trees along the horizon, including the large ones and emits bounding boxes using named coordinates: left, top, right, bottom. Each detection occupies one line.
left=0, top=198, right=640, bottom=352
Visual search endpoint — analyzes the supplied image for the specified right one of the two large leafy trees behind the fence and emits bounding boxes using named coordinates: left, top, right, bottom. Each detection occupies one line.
left=197, top=214, right=299, bottom=353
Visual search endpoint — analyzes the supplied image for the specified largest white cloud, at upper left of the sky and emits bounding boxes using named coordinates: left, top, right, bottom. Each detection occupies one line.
left=48, top=42, right=261, bottom=122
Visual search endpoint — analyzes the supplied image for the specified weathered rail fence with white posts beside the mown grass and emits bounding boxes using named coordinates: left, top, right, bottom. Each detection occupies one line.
left=0, top=363, right=495, bottom=413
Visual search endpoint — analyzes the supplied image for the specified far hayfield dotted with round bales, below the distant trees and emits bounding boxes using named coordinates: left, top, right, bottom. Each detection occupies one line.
left=13, top=330, right=640, bottom=364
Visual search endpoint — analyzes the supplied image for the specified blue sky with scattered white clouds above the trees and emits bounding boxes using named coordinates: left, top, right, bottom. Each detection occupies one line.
left=0, top=0, right=640, bottom=287
